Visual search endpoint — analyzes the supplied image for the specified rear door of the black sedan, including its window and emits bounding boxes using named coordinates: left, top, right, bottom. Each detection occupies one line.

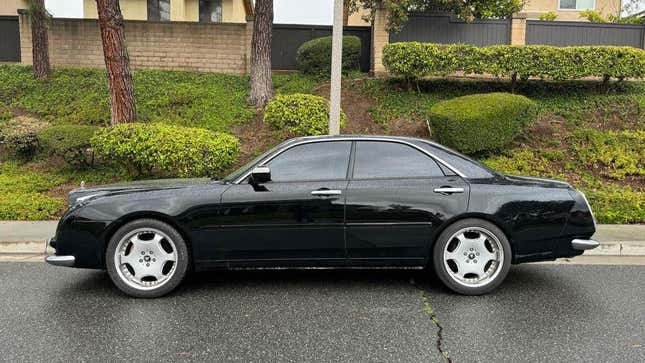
left=346, top=141, right=469, bottom=265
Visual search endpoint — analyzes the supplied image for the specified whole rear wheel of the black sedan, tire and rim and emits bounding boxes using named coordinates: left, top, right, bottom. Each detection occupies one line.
left=432, top=218, right=512, bottom=295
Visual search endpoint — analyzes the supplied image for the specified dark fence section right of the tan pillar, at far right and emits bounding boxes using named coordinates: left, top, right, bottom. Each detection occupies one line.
left=526, top=20, right=645, bottom=48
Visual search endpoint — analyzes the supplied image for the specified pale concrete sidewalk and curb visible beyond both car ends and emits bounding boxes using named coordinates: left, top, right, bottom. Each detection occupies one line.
left=0, top=221, right=645, bottom=261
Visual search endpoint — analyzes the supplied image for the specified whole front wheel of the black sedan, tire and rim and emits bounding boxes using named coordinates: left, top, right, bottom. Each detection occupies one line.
left=105, top=219, right=190, bottom=298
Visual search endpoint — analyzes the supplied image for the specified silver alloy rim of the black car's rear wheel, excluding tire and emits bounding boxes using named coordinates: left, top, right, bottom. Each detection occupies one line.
left=443, top=227, right=504, bottom=287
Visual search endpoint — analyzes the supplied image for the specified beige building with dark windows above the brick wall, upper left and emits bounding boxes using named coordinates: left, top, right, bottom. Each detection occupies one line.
left=83, top=0, right=251, bottom=23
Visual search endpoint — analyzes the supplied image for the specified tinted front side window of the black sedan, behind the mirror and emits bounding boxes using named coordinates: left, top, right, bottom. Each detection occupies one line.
left=267, top=141, right=352, bottom=182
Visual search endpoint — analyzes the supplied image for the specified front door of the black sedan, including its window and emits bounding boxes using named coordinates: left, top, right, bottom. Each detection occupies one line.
left=213, top=141, right=351, bottom=265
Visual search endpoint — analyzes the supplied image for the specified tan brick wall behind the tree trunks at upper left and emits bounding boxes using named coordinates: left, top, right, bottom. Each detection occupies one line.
left=20, top=15, right=253, bottom=73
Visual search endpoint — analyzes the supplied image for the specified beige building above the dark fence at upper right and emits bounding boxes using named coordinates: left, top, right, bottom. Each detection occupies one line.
left=522, top=0, right=622, bottom=21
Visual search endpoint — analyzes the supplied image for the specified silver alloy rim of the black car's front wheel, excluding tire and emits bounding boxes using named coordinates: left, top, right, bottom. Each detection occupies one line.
left=114, top=228, right=178, bottom=290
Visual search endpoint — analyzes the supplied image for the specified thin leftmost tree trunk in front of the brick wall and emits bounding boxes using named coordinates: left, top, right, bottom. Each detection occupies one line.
left=29, top=0, right=51, bottom=79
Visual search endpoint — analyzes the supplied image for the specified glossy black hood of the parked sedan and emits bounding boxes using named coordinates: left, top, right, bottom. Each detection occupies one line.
left=67, top=178, right=214, bottom=206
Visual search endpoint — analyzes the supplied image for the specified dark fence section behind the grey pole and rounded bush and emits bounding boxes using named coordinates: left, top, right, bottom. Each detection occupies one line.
left=271, top=24, right=372, bottom=72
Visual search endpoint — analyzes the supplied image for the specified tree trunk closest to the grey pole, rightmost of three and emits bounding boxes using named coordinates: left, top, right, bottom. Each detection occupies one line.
left=248, top=0, right=273, bottom=108
